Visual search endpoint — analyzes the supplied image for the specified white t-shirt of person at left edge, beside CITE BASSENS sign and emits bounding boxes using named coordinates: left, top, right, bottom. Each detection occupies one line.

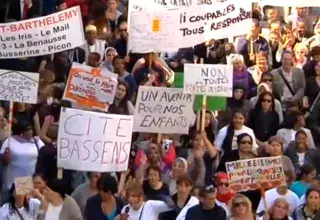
left=0, top=136, right=44, bottom=190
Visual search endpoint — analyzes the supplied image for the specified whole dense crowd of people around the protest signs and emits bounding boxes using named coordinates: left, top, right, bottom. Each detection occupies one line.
left=0, top=0, right=320, bottom=220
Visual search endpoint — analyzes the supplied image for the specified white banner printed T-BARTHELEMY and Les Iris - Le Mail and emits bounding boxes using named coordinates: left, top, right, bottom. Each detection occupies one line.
left=0, top=7, right=85, bottom=59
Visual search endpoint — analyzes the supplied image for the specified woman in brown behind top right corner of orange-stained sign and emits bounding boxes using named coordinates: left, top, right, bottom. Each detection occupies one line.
left=261, top=136, right=295, bottom=176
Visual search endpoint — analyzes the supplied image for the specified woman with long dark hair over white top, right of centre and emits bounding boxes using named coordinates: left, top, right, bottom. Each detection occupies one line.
left=214, top=110, right=258, bottom=160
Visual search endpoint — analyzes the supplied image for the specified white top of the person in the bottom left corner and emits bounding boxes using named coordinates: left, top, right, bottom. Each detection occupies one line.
left=0, top=198, right=41, bottom=220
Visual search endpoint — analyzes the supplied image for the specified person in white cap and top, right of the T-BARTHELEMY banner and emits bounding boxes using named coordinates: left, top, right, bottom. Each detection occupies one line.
left=84, top=24, right=107, bottom=63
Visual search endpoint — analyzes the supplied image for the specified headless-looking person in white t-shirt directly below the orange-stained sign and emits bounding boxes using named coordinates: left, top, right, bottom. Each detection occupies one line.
left=257, top=172, right=299, bottom=215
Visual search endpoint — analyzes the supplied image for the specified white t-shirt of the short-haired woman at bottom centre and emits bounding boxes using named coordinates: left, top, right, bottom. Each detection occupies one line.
left=121, top=200, right=171, bottom=220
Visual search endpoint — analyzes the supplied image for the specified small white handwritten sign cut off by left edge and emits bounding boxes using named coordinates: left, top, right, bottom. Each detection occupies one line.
left=0, top=69, right=39, bottom=104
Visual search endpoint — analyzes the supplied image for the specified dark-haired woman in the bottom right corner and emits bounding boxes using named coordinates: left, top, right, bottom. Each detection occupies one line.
left=293, top=188, right=320, bottom=220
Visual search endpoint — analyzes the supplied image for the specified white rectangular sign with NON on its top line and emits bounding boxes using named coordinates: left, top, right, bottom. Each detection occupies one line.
left=183, top=64, right=233, bottom=97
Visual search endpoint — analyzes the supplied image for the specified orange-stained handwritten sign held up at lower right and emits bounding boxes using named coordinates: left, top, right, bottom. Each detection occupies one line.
left=226, top=156, right=286, bottom=192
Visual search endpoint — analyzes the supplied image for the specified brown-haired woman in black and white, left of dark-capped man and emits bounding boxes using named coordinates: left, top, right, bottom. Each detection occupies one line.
left=161, top=175, right=199, bottom=220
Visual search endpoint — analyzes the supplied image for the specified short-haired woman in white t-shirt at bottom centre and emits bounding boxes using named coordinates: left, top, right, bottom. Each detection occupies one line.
left=115, top=182, right=171, bottom=220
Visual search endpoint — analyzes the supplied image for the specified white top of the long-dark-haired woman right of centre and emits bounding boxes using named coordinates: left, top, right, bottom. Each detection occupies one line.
left=214, top=125, right=258, bottom=151
